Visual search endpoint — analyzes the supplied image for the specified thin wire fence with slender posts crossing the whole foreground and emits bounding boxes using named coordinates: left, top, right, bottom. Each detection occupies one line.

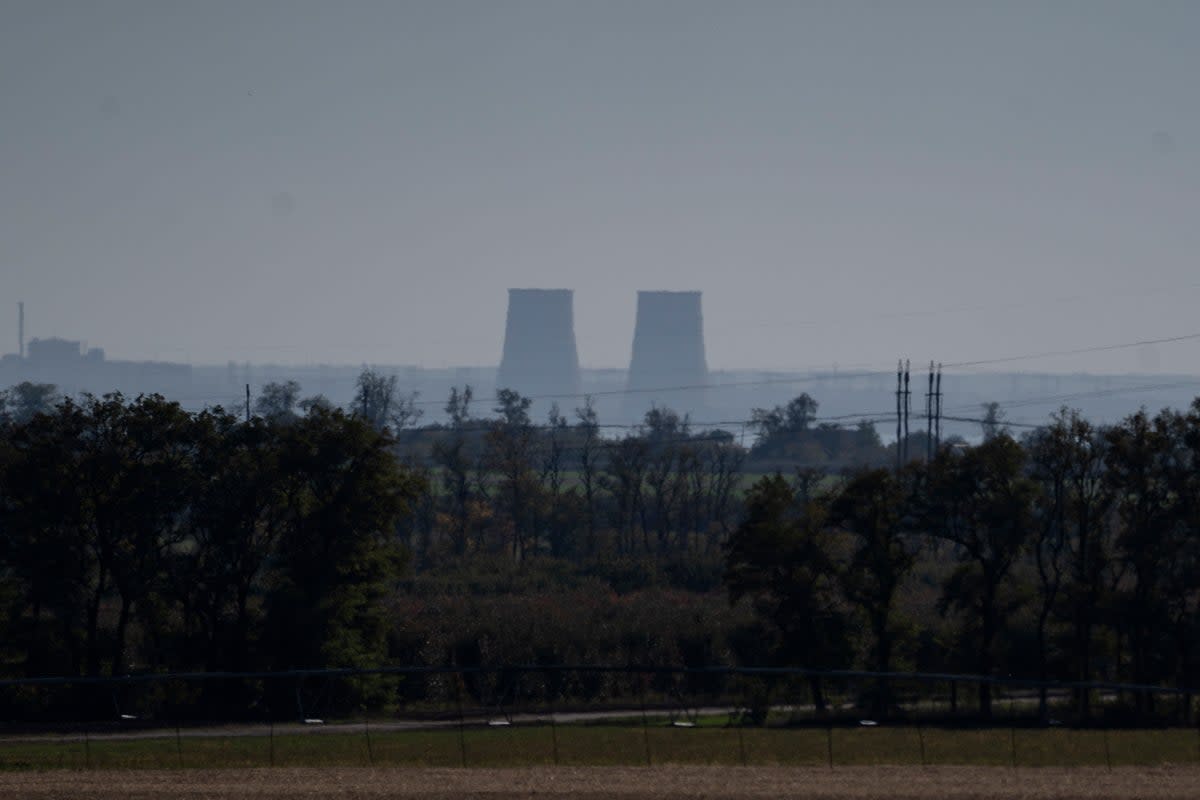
left=0, top=666, right=1200, bottom=769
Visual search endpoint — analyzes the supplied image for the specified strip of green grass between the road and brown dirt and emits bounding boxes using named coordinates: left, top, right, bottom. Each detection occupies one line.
left=0, top=723, right=1200, bottom=770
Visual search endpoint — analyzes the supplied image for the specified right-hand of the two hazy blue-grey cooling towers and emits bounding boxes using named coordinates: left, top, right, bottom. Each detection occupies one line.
left=626, top=291, right=708, bottom=411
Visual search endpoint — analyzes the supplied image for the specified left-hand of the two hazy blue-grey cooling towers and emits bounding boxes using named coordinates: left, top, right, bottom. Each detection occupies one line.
left=496, top=289, right=580, bottom=400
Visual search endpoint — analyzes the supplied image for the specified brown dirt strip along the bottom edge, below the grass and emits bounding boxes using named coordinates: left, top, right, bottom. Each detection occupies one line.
left=0, top=766, right=1200, bottom=800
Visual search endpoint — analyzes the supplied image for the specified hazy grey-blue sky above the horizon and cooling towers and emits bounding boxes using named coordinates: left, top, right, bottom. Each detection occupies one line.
left=0, top=0, right=1200, bottom=372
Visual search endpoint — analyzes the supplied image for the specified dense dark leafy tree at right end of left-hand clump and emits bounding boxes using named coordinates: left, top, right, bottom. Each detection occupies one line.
left=266, top=410, right=420, bottom=686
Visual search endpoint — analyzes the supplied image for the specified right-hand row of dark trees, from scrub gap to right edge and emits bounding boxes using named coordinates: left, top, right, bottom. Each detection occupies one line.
left=725, top=401, right=1200, bottom=715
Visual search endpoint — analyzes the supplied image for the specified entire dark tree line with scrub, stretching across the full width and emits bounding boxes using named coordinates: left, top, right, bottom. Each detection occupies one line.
left=0, top=379, right=1200, bottom=714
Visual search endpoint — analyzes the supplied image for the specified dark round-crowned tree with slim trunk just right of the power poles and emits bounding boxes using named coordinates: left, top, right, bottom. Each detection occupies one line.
left=923, top=434, right=1034, bottom=716
